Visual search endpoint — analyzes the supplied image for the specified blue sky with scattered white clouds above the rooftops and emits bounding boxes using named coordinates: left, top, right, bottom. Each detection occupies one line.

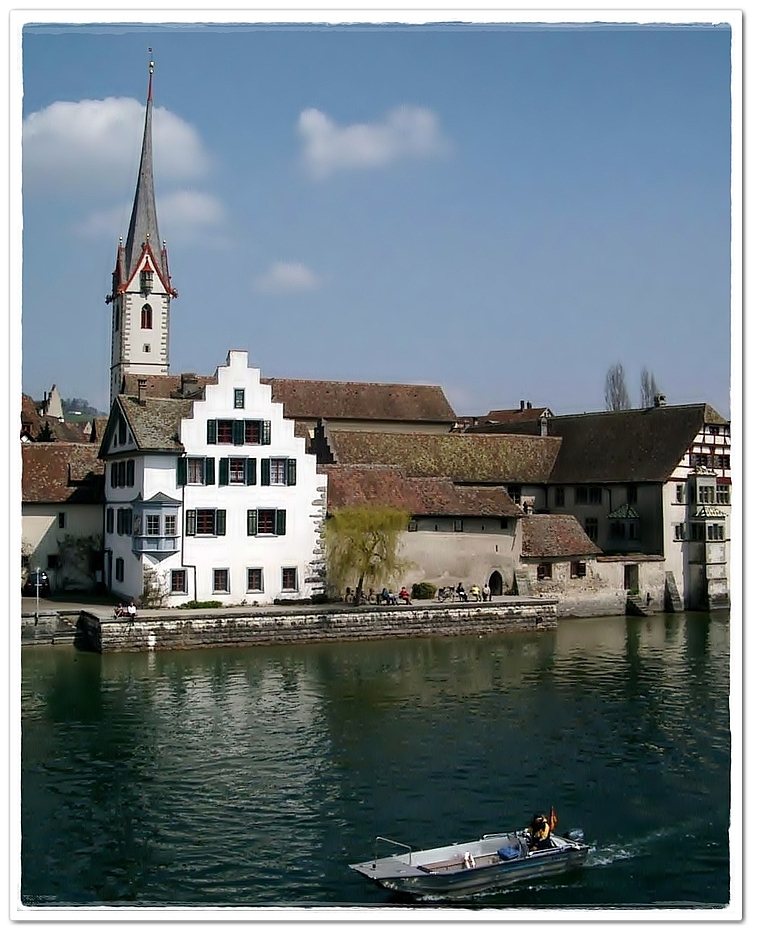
left=17, top=13, right=731, bottom=415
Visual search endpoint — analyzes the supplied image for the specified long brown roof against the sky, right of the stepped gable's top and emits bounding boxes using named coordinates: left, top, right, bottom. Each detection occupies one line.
left=261, top=377, right=456, bottom=424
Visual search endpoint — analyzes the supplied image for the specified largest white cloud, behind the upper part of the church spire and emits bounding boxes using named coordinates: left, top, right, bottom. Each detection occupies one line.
left=22, top=97, right=210, bottom=194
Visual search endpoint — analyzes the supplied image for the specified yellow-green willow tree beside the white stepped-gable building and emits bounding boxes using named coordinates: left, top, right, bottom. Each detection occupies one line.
left=324, top=506, right=410, bottom=604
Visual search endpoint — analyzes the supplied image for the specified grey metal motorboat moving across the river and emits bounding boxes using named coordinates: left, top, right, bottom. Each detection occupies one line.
left=350, top=829, right=589, bottom=896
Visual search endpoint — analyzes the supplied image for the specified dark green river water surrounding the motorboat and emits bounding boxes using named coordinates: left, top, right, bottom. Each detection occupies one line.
left=21, top=613, right=731, bottom=908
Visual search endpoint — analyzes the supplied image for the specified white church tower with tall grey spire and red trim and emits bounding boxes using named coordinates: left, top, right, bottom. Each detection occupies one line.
left=105, top=57, right=178, bottom=404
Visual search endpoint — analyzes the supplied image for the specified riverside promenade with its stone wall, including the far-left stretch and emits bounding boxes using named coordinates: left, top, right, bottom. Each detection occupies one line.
left=21, top=596, right=557, bottom=653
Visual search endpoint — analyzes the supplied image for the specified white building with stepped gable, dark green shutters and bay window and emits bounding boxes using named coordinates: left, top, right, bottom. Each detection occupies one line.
left=100, top=351, right=326, bottom=606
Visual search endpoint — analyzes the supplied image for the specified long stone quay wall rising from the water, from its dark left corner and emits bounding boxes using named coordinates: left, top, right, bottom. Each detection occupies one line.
left=75, top=598, right=557, bottom=653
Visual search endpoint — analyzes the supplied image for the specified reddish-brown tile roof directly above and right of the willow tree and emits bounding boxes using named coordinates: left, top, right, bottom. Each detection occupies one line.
left=323, top=464, right=522, bottom=516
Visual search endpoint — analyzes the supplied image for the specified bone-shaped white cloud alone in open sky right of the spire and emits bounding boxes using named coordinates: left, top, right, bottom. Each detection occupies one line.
left=297, top=106, right=450, bottom=178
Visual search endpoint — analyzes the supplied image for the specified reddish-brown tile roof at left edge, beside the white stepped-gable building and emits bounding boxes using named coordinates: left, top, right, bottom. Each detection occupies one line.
left=21, top=442, right=105, bottom=503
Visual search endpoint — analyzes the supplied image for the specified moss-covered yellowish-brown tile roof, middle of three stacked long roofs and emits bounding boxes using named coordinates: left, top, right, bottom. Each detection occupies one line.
left=326, top=434, right=560, bottom=484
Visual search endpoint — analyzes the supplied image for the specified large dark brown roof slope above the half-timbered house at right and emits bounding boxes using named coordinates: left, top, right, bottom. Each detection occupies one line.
left=549, top=403, right=727, bottom=484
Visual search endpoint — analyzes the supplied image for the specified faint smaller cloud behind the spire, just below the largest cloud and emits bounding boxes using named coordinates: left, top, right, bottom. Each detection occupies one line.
left=74, top=189, right=226, bottom=247
